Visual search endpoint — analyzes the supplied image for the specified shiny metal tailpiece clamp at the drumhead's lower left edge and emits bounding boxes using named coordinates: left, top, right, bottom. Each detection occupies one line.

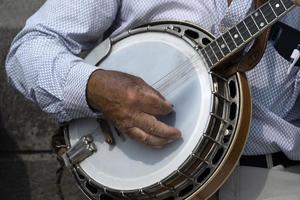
left=62, top=135, right=97, bottom=167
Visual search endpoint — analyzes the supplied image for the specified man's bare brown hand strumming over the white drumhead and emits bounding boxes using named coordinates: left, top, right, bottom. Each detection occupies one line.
left=87, top=70, right=181, bottom=148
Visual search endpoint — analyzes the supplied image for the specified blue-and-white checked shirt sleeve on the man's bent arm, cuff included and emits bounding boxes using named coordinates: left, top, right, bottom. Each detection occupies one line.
left=6, top=0, right=119, bottom=122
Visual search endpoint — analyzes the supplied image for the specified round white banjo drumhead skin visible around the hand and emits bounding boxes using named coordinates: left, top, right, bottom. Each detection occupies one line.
left=69, top=32, right=212, bottom=190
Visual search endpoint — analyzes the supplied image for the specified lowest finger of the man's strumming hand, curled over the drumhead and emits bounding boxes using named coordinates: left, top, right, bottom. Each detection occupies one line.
left=126, top=127, right=173, bottom=148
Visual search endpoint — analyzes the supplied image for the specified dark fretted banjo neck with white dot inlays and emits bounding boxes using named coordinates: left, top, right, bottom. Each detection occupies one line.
left=201, top=0, right=295, bottom=69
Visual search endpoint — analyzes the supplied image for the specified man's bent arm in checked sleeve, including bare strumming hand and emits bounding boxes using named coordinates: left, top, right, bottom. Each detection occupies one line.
left=6, top=0, right=180, bottom=147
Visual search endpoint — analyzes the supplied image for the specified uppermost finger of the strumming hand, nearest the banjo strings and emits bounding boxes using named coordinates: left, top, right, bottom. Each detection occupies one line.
left=140, top=86, right=173, bottom=115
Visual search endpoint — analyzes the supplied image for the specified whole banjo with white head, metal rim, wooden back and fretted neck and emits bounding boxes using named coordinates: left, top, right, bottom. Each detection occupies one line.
left=57, top=0, right=294, bottom=200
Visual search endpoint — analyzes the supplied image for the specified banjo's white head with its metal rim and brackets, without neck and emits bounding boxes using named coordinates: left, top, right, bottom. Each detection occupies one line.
left=66, top=20, right=251, bottom=200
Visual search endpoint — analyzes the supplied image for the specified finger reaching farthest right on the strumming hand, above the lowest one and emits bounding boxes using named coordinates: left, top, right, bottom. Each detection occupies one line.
left=134, top=113, right=181, bottom=139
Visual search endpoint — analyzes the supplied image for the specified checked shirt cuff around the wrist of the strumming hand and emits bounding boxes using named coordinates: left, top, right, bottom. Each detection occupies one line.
left=63, top=62, right=99, bottom=121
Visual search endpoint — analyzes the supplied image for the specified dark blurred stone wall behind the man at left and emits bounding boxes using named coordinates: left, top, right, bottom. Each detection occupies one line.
left=0, top=0, right=84, bottom=200
